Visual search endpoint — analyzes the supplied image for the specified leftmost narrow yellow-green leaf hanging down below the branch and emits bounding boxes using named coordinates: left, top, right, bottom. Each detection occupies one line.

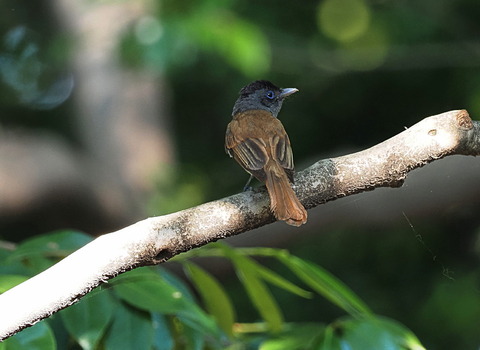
left=184, top=263, right=235, bottom=336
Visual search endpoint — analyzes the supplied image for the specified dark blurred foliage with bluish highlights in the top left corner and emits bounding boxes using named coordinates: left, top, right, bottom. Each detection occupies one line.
left=0, top=0, right=75, bottom=137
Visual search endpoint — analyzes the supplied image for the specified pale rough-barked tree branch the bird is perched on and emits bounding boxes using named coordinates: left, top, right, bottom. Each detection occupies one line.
left=0, top=110, right=474, bottom=340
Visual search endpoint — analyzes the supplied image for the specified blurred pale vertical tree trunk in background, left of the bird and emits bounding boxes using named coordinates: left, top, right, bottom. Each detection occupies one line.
left=56, top=0, right=174, bottom=211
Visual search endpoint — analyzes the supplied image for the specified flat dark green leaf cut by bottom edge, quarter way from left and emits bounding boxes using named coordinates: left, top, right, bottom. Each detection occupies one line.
left=105, top=303, right=154, bottom=350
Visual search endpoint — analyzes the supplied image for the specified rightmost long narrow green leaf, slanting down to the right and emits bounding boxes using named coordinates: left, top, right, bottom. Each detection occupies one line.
left=278, top=255, right=372, bottom=317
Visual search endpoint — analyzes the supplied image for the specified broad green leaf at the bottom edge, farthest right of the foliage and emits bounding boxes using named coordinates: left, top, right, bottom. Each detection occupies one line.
left=320, top=317, right=425, bottom=350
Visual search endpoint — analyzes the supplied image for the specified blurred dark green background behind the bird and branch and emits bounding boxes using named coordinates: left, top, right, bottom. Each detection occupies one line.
left=0, top=0, right=480, bottom=349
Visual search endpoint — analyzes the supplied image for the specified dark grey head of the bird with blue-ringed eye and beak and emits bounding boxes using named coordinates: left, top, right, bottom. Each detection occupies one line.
left=232, top=80, right=298, bottom=118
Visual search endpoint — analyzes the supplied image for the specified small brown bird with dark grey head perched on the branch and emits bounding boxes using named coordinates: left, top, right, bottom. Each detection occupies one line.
left=225, top=80, right=307, bottom=226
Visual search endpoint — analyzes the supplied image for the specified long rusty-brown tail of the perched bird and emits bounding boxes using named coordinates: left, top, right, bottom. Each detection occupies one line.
left=265, top=162, right=307, bottom=226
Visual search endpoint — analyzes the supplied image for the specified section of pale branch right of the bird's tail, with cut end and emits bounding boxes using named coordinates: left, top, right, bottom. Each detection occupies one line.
left=297, top=110, right=480, bottom=208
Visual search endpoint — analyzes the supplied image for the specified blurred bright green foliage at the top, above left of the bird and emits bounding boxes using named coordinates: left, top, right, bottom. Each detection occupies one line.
left=121, top=1, right=270, bottom=78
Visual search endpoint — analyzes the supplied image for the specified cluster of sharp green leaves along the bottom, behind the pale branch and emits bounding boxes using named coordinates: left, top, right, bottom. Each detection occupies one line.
left=0, top=231, right=424, bottom=350
